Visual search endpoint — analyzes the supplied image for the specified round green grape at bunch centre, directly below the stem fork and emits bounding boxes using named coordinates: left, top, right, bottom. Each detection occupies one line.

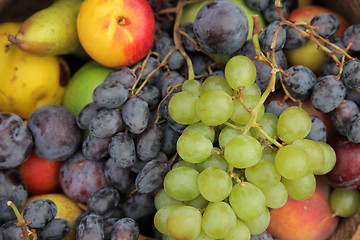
left=224, top=135, right=262, bottom=168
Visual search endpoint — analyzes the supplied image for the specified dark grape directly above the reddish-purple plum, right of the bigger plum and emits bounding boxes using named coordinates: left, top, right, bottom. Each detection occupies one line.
left=82, top=133, right=112, bottom=160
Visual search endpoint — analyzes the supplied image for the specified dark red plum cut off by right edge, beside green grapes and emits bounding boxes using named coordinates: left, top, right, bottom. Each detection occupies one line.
left=325, top=136, right=360, bottom=189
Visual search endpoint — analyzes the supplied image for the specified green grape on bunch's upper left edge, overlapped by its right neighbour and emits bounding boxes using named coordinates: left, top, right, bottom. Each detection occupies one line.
left=168, top=92, right=200, bottom=124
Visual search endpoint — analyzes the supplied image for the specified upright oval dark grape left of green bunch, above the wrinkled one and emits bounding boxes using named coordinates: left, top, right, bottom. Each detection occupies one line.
left=136, top=123, right=163, bottom=161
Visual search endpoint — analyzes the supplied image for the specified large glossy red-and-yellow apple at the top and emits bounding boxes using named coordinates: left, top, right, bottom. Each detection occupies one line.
left=77, top=0, right=155, bottom=67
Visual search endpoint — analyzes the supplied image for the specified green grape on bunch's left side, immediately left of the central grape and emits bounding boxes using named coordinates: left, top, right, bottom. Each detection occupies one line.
left=176, top=132, right=213, bottom=163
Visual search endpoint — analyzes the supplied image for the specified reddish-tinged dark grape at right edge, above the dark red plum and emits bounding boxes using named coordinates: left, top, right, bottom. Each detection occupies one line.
left=331, top=100, right=359, bottom=136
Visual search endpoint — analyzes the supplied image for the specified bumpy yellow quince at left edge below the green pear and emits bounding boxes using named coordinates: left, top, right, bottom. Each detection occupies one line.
left=0, top=22, right=70, bottom=118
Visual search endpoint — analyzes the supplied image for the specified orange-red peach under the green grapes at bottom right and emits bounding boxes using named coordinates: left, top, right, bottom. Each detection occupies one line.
left=267, top=177, right=339, bottom=240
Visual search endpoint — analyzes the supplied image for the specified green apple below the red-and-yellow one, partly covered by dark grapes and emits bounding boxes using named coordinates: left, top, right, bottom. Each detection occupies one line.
left=63, top=61, right=113, bottom=116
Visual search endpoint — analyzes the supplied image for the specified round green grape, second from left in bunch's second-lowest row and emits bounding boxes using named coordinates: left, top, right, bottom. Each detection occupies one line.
left=198, top=167, right=232, bottom=202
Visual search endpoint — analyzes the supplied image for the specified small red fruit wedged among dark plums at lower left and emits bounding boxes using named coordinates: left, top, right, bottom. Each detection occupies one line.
left=18, top=152, right=62, bottom=195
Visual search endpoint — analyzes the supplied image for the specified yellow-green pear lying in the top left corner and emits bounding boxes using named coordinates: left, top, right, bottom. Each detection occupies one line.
left=8, top=0, right=83, bottom=56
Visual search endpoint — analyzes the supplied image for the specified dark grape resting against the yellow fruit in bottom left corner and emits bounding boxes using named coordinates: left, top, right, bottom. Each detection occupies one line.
left=23, top=199, right=57, bottom=228
